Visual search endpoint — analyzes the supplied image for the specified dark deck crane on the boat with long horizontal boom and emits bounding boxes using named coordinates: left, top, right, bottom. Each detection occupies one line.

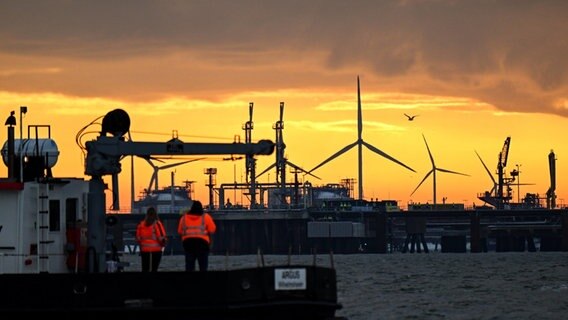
left=85, top=109, right=275, bottom=271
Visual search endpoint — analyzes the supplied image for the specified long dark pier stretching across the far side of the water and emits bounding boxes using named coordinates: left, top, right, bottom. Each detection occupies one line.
left=107, top=209, right=568, bottom=255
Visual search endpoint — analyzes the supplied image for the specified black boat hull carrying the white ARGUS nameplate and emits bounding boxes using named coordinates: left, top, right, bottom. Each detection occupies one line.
left=0, top=266, right=341, bottom=319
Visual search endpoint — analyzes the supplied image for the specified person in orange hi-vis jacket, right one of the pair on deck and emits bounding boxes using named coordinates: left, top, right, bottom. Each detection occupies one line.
left=178, top=200, right=217, bottom=271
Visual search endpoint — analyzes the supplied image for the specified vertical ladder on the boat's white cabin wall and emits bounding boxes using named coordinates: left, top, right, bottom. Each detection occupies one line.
left=37, top=182, right=53, bottom=273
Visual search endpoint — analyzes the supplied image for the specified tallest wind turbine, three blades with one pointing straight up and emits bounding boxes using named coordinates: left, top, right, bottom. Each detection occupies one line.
left=308, top=76, right=416, bottom=200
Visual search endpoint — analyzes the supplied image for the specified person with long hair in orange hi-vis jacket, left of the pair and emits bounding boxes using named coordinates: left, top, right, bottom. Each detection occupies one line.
left=136, top=207, right=168, bottom=272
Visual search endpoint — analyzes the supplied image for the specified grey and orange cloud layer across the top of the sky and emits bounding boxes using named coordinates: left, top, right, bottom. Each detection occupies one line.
left=0, top=0, right=568, bottom=116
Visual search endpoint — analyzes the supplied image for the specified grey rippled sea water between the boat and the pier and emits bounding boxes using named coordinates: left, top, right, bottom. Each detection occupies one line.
left=124, top=251, right=568, bottom=320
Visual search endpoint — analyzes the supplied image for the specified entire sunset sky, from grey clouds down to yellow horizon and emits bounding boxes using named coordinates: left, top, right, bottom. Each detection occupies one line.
left=0, top=0, right=568, bottom=211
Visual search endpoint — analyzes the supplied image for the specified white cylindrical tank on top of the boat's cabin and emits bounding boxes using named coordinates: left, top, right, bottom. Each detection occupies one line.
left=2, top=139, right=59, bottom=168
